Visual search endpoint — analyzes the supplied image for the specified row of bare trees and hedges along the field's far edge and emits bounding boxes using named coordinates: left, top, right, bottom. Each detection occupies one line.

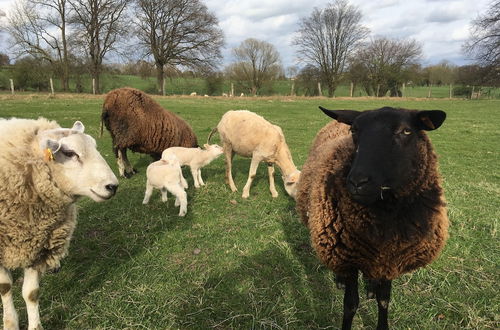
left=0, top=0, right=500, bottom=96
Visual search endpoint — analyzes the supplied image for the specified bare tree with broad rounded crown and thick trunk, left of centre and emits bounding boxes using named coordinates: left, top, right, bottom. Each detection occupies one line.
left=135, top=0, right=224, bottom=94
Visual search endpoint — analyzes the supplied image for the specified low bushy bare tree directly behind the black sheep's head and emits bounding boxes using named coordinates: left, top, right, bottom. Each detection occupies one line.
left=351, top=38, right=422, bottom=96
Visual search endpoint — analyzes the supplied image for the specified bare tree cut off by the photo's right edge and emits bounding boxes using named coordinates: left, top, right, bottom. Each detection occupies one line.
left=463, top=0, right=500, bottom=66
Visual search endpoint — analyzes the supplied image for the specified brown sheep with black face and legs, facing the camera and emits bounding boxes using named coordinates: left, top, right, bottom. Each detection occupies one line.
left=297, top=107, right=448, bottom=329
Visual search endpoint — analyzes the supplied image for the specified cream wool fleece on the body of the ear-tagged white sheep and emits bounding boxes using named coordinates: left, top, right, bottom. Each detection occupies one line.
left=0, top=119, right=76, bottom=272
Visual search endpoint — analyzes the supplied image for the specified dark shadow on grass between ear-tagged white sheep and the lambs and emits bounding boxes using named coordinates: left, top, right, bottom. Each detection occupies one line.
left=39, top=184, right=193, bottom=329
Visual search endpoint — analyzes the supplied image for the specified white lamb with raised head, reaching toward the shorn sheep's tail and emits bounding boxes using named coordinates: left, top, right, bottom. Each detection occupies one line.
left=161, top=144, right=224, bottom=188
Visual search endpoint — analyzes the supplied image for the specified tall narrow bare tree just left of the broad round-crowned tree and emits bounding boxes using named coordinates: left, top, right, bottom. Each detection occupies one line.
left=67, top=0, right=128, bottom=93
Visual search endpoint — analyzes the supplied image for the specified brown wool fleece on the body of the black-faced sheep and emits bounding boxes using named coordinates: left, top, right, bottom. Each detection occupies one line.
left=297, top=121, right=448, bottom=280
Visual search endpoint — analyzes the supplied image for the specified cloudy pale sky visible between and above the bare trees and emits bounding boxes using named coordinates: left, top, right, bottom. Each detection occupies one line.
left=0, top=0, right=492, bottom=68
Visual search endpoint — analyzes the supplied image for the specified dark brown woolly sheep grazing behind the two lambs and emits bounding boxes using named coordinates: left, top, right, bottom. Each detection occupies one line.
left=101, top=88, right=198, bottom=178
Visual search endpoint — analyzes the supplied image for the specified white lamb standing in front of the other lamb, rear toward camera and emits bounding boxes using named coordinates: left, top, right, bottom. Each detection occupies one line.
left=142, top=154, right=187, bottom=217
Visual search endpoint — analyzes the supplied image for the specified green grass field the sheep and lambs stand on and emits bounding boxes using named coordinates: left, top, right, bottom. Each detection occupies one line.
left=0, top=95, right=500, bottom=329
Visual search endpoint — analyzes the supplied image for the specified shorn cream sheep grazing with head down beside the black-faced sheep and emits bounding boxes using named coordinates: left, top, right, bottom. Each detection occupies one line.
left=208, top=110, right=300, bottom=198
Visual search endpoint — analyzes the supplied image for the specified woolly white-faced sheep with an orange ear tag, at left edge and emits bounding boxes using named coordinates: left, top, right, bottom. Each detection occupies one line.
left=0, top=118, right=118, bottom=329
